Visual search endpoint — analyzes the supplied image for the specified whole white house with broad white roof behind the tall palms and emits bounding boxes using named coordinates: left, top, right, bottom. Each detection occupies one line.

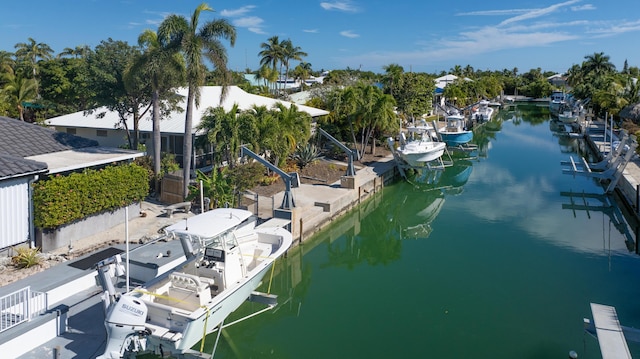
left=46, top=86, right=329, bottom=168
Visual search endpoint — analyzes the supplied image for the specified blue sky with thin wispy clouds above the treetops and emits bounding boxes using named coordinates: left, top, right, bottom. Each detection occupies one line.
left=0, top=0, right=640, bottom=73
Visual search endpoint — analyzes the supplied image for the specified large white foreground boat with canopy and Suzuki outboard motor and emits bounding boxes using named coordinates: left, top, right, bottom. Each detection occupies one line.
left=98, top=208, right=292, bottom=359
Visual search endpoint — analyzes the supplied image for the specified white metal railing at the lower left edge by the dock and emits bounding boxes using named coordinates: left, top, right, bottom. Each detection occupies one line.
left=0, top=287, right=47, bottom=332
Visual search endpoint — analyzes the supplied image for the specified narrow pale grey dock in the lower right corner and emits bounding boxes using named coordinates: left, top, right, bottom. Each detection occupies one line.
left=591, top=303, right=631, bottom=359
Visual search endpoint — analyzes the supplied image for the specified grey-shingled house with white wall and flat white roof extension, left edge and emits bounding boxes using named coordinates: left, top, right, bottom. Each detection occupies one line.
left=0, top=116, right=142, bottom=252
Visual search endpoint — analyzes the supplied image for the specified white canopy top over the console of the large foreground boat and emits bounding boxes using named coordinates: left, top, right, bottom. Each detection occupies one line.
left=165, top=208, right=253, bottom=238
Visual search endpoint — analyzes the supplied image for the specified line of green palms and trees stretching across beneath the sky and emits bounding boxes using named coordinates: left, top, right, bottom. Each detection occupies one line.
left=0, top=3, right=640, bottom=200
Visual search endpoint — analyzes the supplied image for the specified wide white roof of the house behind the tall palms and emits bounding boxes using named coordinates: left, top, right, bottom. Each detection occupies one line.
left=46, top=86, right=329, bottom=134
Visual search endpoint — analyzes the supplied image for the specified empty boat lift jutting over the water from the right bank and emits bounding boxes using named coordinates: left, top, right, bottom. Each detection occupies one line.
left=560, top=132, right=638, bottom=193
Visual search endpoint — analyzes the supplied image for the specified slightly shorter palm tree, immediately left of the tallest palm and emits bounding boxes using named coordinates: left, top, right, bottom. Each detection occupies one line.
left=126, top=30, right=184, bottom=193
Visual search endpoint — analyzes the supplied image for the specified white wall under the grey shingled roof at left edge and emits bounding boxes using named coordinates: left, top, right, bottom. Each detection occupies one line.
left=0, top=177, right=31, bottom=249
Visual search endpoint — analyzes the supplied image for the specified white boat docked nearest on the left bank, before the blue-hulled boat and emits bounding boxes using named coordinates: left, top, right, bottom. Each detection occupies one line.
left=389, top=126, right=447, bottom=167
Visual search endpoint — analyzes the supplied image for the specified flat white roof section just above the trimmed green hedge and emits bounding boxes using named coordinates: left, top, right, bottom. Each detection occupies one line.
left=25, top=147, right=144, bottom=174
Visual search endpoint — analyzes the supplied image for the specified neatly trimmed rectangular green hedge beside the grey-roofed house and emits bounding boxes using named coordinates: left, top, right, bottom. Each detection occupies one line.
left=33, top=164, right=149, bottom=229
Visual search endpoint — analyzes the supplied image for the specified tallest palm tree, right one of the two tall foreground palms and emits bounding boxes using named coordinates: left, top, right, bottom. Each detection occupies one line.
left=158, top=3, right=236, bottom=197
